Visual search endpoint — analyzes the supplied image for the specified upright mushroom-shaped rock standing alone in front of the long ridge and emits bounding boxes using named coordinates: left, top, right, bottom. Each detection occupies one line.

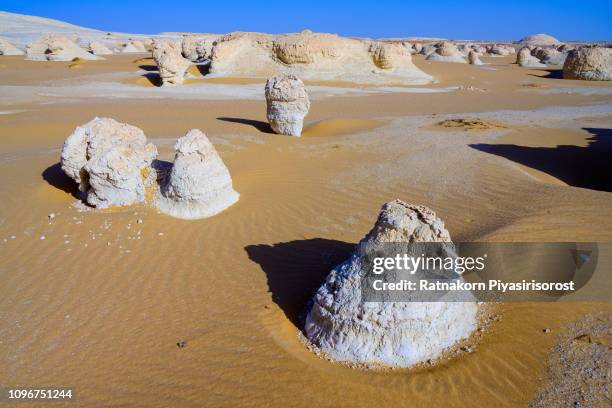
left=266, top=75, right=310, bottom=136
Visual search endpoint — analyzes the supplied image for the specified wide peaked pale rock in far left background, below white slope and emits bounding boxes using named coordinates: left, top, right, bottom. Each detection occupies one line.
left=26, top=33, right=99, bottom=61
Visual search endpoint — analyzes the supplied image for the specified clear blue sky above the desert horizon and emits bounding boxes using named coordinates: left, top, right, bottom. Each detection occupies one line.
left=0, top=0, right=612, bottom=40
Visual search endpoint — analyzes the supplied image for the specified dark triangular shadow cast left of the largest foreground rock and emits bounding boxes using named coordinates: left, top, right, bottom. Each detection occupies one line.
left=244, top=238, right=355, bottom=330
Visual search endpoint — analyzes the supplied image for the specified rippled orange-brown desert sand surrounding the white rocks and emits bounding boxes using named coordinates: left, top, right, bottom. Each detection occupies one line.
left=0, top=55, right=612, bottom=407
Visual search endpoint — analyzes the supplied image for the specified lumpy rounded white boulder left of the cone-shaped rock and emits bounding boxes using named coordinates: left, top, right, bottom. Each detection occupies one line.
left=61, top=118, right=157, bottom=208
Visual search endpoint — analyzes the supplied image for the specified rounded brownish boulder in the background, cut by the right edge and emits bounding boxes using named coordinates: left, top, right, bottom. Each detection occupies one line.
left=563, top=47, right=612, bottom=81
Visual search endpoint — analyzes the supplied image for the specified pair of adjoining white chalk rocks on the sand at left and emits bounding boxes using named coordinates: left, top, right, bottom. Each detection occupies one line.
left=61, top=118, right=239, bottom=219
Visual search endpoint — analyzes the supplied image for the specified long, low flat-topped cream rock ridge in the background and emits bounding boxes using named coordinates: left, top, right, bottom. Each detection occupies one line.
left=210, top=30, right=432, bottom=84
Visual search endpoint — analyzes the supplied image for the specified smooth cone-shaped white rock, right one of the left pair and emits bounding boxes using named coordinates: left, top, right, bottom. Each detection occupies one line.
left=155, top=129, right=239, bottom=219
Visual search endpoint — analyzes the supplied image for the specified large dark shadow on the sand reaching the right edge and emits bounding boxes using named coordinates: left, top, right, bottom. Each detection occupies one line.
left=469, top=128, right=612, bottom=192
